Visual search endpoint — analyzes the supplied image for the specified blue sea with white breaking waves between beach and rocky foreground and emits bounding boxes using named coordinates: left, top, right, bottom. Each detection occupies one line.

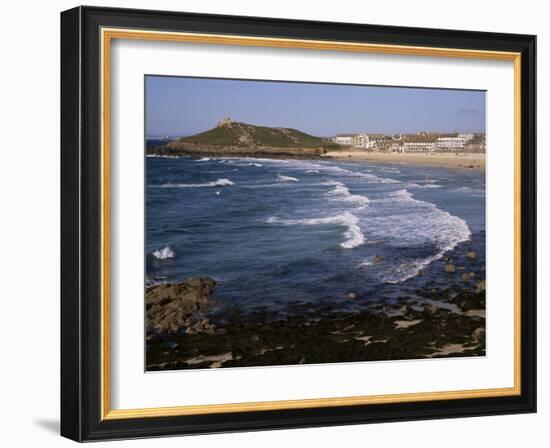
left=145, top=156, right=485, bottom=318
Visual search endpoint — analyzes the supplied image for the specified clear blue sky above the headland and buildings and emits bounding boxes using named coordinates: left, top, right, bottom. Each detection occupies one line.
left=145, top=76, right=485, bottom=137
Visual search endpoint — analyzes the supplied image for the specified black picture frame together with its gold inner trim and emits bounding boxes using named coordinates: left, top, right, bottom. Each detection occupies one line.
left=61, top=7, right=536, bottom=442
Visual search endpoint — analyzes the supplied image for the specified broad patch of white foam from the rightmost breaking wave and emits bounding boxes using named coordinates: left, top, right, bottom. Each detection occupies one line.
left=365, top=189, right=471, bottom=283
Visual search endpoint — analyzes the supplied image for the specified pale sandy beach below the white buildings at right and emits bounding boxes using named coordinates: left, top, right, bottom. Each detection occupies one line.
left=324, top=149, right=485, bottom=170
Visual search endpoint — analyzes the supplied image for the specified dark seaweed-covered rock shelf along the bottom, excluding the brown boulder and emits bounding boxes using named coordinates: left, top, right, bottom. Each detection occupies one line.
left=146, top=285, right=485, bottom=370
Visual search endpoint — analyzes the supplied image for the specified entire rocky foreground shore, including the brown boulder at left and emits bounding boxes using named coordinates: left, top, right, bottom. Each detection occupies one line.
left=146, top=272, right=485, bottom=370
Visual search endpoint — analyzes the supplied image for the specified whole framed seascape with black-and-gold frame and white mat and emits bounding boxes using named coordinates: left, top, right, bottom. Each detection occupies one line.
left=61, top=7, right=536, bottom=441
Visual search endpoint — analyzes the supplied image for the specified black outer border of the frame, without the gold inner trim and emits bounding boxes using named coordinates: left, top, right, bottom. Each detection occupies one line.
left=61, top=6, right=537, bottom=442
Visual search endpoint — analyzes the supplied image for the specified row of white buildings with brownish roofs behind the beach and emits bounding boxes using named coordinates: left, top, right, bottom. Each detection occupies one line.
left=332, top=133, right=474, bottom=152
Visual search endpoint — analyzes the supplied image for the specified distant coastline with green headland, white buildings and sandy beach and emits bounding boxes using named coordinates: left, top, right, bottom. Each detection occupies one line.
left=147, top=118, right=485, bottom=170
